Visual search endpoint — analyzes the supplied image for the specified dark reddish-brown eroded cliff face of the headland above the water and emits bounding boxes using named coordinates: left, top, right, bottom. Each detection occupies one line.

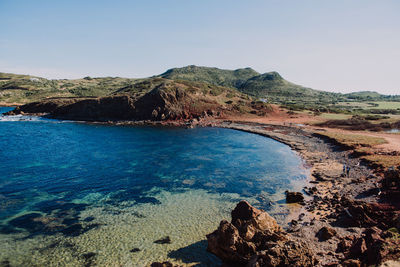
left=6, top=83, right=228, bottom=121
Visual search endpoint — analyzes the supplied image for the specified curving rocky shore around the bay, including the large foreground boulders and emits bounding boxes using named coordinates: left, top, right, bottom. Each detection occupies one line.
left=208, top=121, right=400, bottom=266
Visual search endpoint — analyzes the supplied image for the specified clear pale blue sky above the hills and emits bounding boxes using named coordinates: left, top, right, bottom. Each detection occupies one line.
left=0, top=0, right=400, bottom=94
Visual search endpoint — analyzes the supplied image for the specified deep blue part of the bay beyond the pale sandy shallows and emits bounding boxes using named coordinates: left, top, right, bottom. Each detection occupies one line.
left=0, top=108, right=305, bottom=266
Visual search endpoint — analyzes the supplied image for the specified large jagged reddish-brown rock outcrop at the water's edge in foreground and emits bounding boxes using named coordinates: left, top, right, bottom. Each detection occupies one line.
left=207, top=201, right=316, bottom=266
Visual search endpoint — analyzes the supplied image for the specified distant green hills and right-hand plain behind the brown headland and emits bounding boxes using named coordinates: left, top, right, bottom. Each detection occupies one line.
left=0, top=65, right=400, bottom=114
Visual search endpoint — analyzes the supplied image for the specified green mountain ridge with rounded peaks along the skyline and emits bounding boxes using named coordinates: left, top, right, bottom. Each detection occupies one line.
left=0, top=65, right=400, bottom=109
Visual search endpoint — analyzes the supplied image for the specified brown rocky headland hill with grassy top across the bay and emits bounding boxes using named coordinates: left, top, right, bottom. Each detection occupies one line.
left=8, top=78, right=269, bottom=121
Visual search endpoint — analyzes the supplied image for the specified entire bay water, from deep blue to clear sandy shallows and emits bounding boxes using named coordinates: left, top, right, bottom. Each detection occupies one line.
left=0, top=108, right=308, bottom=266
